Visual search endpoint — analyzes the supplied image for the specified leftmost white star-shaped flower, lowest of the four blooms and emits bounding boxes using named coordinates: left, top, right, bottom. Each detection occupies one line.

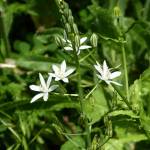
left=29, top=73, right=58, bottom=103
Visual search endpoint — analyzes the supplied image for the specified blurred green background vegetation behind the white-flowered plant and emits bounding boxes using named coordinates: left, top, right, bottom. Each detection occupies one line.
left=0, top=0, right=150, bottom=150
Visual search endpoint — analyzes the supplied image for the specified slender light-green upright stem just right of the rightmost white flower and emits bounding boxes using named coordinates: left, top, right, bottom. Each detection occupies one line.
left=121, top=43, right=129, bottom=102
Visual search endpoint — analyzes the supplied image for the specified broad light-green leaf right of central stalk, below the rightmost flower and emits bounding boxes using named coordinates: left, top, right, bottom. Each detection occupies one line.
left=84, top=87, right=108, bottom=124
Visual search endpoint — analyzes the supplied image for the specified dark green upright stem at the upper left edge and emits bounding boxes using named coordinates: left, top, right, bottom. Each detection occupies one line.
left=0, top=4, right=10, bottom=57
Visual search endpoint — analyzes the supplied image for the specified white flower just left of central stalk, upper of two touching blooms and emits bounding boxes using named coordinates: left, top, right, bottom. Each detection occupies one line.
left=49, top=60, right=75, bottom=83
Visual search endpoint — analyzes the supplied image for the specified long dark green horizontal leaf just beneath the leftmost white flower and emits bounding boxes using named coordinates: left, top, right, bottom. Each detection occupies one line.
left=0, top=95, right=79, bottom=111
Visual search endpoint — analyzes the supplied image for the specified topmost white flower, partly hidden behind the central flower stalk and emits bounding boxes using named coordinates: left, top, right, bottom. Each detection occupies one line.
left=63, top=37, right=91, bottom=55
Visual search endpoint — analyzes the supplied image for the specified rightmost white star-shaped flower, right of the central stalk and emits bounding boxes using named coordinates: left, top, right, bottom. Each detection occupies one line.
left=94, top=60, right=122, bottom=86
